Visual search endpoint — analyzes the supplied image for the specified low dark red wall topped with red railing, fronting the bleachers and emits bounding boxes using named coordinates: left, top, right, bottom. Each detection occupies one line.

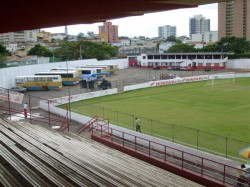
left=91, top=126, right=250, bottom=186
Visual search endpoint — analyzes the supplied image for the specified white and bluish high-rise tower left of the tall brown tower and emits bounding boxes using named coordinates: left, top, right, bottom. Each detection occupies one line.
left=189, top=15, right=210, bottom=37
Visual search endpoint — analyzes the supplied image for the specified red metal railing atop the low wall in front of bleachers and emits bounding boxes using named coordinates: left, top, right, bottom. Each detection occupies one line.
left=92, top=126, right=250, bottom=186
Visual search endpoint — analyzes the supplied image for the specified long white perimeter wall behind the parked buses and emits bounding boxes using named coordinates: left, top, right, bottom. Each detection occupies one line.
left=0, top=58, right=128, bottom=88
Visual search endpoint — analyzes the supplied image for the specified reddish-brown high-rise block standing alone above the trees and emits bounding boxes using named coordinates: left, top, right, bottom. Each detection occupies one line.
left=98, top=22, right=119, bottom=43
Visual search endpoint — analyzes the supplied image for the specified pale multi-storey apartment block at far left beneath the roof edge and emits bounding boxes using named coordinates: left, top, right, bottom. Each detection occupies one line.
left=0, top=30, right=39, bottom=44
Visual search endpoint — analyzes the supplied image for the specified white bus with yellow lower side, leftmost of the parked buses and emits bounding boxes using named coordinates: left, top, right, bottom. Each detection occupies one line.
left=15, top=75, right=62, bottom=91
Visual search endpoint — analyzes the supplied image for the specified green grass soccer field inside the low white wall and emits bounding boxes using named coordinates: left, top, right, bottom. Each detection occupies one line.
left=65, top=78, right=250, bottom=159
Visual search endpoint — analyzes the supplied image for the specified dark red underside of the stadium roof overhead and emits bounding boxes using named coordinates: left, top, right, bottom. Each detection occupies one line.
left=0, top=0, right=225, bottom=33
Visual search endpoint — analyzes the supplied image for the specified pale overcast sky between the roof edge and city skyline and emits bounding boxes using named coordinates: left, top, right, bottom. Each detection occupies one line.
left=42, top=3, right=218, bottom=37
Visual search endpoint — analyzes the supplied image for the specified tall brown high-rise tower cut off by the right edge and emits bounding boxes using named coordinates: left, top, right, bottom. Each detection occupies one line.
left=218, top=0, right=250, bottom=41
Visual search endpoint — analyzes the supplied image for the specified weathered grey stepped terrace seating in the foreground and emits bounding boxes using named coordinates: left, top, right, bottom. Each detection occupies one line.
left=0, top=119, right=203, bottom=187
